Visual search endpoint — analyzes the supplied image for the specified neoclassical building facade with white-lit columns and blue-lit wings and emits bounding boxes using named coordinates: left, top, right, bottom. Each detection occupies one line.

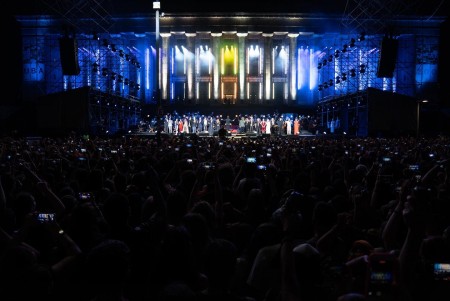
left=17, top=12, right=444, bottom=106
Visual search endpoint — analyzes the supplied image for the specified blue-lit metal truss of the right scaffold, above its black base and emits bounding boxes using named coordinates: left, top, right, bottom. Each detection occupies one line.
left=319, top=0, right=428, bottom=100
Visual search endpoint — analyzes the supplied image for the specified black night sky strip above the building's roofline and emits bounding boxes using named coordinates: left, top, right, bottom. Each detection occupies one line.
left=8, top=0, right=449, bottom=16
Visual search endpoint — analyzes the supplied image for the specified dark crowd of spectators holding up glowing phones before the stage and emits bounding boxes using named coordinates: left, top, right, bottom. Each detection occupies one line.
left=0, top=134, right=450, bottom=301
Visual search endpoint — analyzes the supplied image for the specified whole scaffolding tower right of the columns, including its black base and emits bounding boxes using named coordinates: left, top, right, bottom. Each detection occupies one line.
left=317, top=0, right=437, bottom=136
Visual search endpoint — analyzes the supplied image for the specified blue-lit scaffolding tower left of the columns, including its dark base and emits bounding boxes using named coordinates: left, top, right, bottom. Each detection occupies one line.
left=30, top=0, right=142, bottom=134
